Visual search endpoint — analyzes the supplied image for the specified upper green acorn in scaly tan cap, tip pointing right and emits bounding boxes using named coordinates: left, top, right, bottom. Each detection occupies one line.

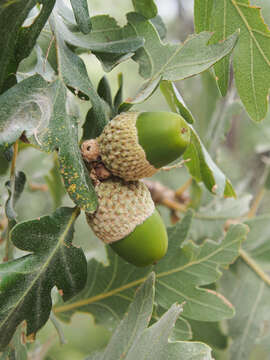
left=96, top=112, right=190, bottom=181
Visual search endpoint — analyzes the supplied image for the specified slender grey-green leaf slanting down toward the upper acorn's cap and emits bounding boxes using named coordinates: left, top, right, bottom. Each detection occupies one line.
left=50, top=13, right=108, bottom=136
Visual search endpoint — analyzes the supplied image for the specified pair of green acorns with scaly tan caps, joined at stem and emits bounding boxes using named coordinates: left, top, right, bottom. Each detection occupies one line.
left=82, top=112, right=190, bottom=266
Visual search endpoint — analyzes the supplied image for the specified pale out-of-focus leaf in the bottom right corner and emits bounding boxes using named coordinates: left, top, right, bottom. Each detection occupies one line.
left=222, top=261, right=270, bottom=360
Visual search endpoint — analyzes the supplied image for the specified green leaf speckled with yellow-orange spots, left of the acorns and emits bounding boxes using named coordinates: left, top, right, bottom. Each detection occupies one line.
left=33, top=80, right=97, bottom=212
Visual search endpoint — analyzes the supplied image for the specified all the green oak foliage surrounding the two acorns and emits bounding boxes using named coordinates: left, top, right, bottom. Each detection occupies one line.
left=0, top=0, right=270, bottom=360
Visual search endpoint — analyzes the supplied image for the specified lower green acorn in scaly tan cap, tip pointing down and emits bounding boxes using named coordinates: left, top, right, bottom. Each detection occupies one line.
left=86, top=178, right=168, bottom=266
